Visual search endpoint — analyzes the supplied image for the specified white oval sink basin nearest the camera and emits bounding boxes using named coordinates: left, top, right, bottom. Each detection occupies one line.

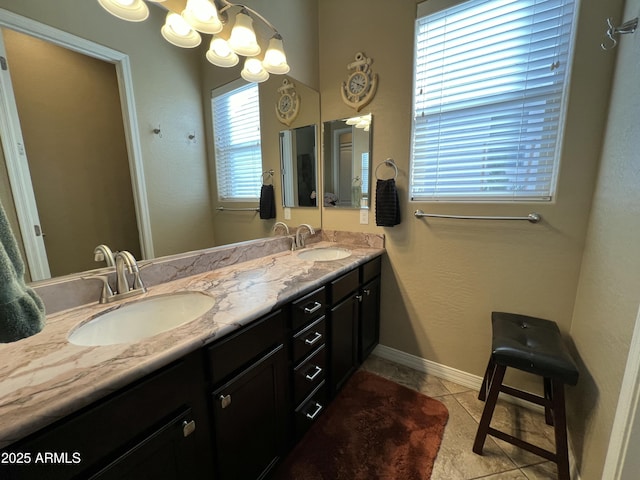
left=69, top=292, right=215, bottom=346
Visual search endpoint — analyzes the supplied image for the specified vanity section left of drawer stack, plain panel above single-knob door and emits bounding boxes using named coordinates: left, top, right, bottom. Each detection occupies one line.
left=206, top=311, right=289, bottom=480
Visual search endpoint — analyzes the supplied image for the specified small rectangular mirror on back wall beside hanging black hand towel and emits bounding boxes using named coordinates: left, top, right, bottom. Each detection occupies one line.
left=323, top=114, right=373, bottom=208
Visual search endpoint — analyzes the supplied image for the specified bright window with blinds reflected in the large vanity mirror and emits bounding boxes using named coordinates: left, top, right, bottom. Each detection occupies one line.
left=211, top=81, right=262, bottom=201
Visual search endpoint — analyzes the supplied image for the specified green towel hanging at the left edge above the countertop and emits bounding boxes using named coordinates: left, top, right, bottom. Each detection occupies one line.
left=0, top=204, right=45, bottom=343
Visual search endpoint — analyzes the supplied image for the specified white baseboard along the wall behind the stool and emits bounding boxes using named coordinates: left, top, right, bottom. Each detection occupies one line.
left=372, top=345, right=580, bottom=480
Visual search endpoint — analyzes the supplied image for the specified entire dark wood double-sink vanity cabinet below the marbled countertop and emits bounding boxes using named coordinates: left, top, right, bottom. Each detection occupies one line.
left=0, top=253, right=380, bottom=480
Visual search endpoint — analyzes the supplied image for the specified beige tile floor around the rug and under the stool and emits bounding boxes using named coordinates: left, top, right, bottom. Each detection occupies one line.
left=362, top=355, right=557, bottom=480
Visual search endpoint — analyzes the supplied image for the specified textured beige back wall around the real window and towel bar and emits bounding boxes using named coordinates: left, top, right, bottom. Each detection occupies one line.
left=319, top=0, right=620, bottom=389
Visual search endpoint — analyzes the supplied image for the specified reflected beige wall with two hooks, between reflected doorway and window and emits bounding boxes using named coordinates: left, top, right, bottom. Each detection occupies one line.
left=0, top=0, right=214, bottom=256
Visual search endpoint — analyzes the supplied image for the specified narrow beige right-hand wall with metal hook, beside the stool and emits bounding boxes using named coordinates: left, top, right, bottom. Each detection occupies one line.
left=568, top=0, right=640, bottom=480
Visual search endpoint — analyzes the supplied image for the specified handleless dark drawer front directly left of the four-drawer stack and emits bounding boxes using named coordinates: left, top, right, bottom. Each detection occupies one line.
left=206, top=310, right=286, bottom=383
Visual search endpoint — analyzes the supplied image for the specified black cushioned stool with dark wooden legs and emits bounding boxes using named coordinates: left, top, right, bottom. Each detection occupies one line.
left=473, top=312, right=578, bottom=480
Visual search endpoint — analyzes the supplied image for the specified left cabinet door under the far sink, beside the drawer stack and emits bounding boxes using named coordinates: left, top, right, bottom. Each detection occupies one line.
left=329, top=294, right=360, bottom=396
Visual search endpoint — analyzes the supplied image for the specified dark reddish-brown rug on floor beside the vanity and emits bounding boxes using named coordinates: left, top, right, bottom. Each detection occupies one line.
left=270, top=371, right=449, bottom=480
